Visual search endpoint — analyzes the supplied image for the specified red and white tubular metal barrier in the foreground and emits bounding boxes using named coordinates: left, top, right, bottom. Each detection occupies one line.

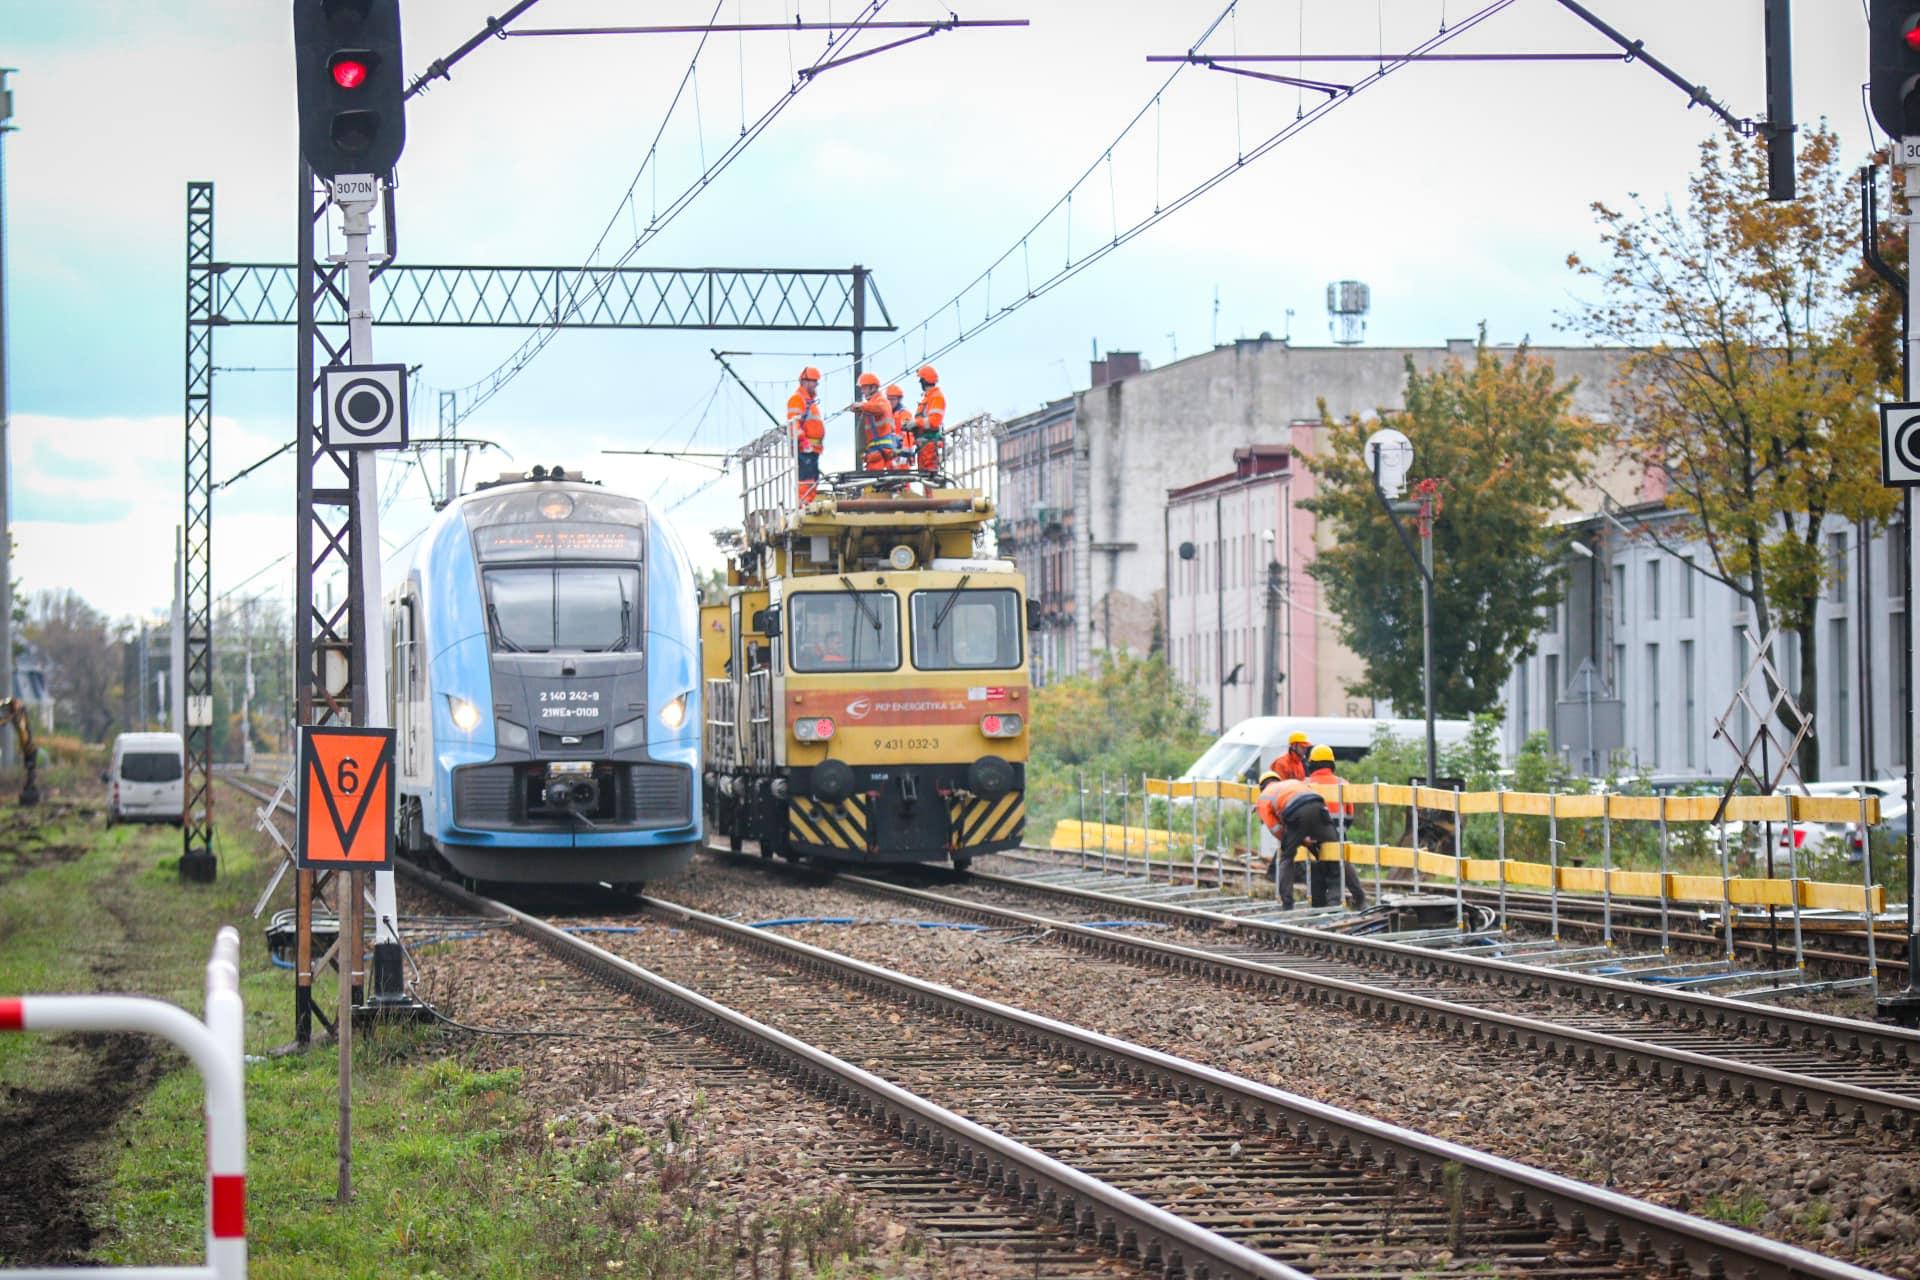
left=0, top=927, right=246, bottom=1280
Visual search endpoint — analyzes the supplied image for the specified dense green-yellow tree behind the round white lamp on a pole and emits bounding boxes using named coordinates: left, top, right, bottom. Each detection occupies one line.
left=1302, top=332, right=1603, bottom=716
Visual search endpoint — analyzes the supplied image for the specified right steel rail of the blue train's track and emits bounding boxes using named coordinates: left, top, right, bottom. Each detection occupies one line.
left=643, top=877, right=1876, bottom=1280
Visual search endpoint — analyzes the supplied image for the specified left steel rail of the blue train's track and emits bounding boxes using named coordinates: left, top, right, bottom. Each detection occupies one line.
left=396, top=862, right=1305, bottom=1280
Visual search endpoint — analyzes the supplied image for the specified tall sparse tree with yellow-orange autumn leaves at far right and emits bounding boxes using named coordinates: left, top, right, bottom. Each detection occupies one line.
left=1567, top=123, right=1899, bottom=777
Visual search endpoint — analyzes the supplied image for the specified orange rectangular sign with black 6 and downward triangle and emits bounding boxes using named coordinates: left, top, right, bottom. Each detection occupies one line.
left=294, top=725, right=394, bottom=871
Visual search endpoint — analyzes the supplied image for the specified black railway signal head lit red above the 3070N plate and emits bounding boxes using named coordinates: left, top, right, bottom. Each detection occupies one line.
left=294, top=0, right=407, bottom=178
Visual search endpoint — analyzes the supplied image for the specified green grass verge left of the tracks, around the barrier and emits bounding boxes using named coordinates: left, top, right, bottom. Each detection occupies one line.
left=0, top=787, right=858, bottom=1278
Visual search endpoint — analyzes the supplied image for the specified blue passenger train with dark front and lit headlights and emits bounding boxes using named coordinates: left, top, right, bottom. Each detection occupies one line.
left=386, top=466, right=701, bottom=885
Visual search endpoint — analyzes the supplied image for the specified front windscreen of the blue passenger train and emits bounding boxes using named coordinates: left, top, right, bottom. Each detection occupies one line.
left=486, top=568, right=639, bottom=652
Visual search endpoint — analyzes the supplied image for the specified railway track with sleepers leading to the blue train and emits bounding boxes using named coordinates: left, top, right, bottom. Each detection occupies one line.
left=224, top=775, right=1874, bottom=1278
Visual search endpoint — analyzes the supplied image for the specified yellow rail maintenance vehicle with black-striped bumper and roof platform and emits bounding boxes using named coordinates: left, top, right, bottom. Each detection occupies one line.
left=701, top=420, right=1031, bottom=867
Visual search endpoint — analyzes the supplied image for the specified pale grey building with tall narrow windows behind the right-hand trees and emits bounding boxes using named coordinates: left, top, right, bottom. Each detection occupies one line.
left=1505, top=503, right=1908, bottom=781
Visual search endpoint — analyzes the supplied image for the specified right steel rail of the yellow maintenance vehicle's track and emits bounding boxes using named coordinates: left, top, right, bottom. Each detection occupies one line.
left=962, top=871, right=1920, bottom=1063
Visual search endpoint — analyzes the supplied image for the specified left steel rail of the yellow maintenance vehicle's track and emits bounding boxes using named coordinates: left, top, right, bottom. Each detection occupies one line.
left=802, top=875, right=1920, bottom=1128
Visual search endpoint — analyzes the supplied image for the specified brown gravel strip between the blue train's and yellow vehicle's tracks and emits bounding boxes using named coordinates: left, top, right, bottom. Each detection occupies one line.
left=659, top=858, right=1920, bottom=1276
